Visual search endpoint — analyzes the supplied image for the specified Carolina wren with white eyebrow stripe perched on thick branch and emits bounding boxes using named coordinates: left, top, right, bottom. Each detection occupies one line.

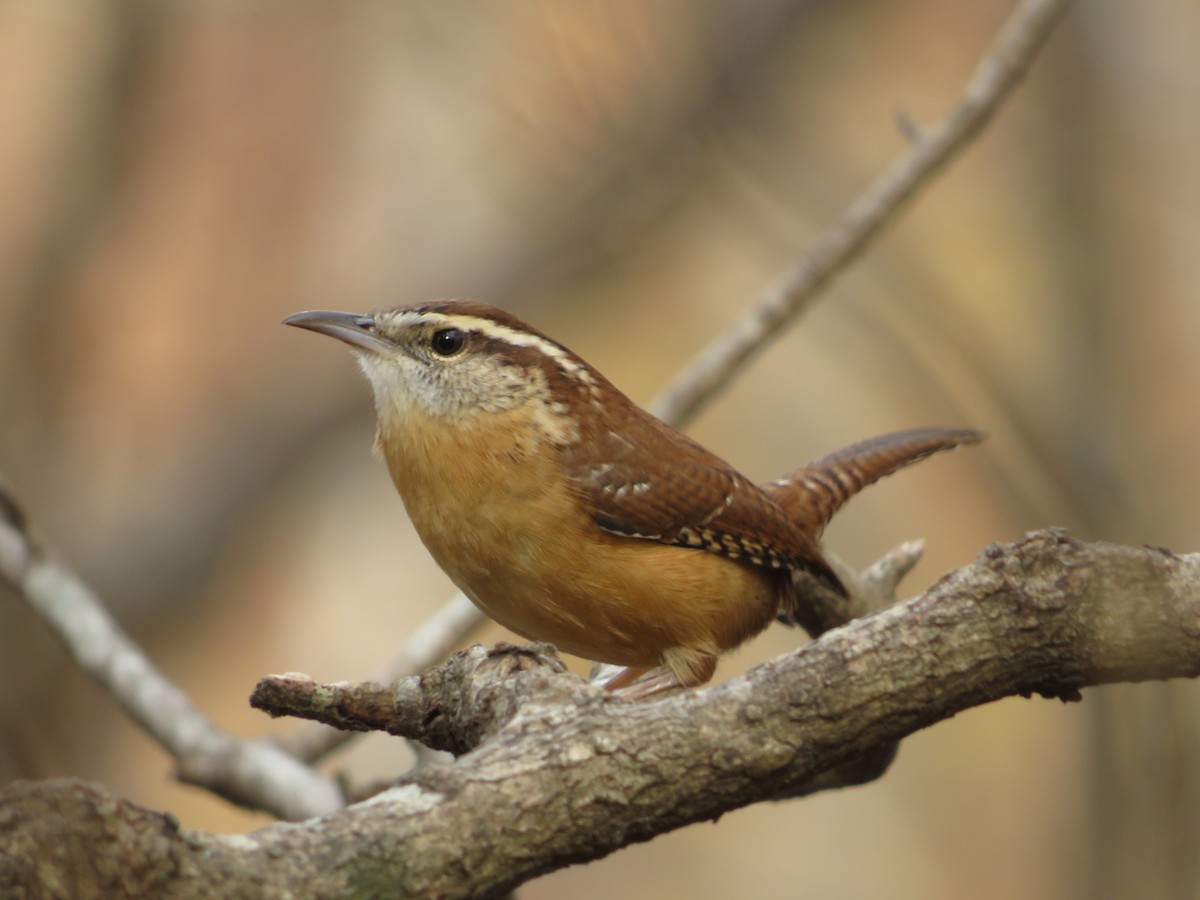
left=283, top=300, right=982, bottom=696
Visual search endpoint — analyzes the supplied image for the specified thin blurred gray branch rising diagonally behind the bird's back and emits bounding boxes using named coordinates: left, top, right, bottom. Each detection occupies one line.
left=652, top=0, right=1069, bottom=422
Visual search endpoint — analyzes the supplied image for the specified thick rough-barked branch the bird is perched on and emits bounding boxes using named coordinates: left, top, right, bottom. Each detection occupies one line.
left=0, top=530, right=1200, bottom=898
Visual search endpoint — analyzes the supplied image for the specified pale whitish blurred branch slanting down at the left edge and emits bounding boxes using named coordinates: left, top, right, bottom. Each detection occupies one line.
left=0, top=485, right=342, bottom=820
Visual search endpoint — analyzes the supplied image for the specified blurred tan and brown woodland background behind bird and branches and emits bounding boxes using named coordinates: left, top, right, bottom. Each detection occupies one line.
left=0, top=0, right=1200, bottom=898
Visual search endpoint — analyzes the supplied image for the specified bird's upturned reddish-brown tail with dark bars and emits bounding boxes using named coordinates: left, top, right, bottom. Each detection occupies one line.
left=762, top=428, right=983, bottom=538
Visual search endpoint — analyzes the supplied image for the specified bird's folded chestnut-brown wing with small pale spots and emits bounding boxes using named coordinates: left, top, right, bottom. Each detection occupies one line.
left=563, top=402, right=841, bottom=588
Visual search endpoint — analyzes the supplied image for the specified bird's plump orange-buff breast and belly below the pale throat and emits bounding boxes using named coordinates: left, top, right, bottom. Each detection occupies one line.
left=388, top=415, right=790, bottom=667
